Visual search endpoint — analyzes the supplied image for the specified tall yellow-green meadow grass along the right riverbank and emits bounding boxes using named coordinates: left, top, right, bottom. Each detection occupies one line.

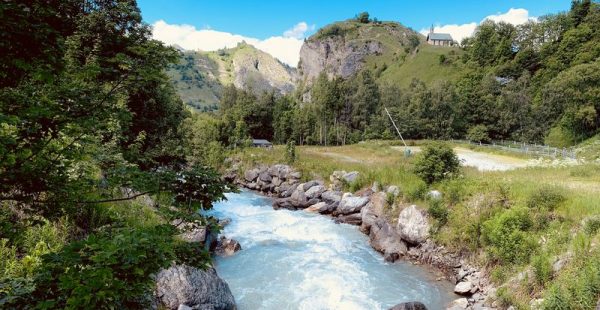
left=234, top=142, right=600, bottom=309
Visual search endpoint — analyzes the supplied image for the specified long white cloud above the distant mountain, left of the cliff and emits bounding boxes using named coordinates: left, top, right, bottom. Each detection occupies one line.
left=152, top=20, right=315, bottom=67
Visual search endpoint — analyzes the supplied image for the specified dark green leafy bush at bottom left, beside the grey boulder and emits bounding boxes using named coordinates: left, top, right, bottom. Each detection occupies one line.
left=29, top=225, right=177, bottom=309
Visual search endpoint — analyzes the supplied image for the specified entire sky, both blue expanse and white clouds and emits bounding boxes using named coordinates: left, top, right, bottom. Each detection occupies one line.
left=138, top=0, right=571, bottom=66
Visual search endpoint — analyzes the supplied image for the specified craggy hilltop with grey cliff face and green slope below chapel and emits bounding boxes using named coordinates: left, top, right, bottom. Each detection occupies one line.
left=299, top=19, right=464, bottom=86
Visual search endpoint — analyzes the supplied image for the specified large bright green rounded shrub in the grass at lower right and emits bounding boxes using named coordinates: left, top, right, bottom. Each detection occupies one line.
left=482, top=208, right=536, bottom=264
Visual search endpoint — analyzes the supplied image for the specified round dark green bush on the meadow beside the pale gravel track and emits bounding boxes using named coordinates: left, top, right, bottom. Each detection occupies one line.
left=414, top=142, right=460, bottom=184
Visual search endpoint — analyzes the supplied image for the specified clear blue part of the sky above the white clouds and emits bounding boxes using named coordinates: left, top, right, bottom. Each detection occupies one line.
left=138, top=0, right=571, bottom=39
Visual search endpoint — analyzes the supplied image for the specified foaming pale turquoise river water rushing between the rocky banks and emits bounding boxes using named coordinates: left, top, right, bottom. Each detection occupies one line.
left=210, top=192, right=453, bottom=310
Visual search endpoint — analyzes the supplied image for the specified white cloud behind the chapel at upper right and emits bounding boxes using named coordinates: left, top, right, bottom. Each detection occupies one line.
left=420, top=9, right=537, bottom=43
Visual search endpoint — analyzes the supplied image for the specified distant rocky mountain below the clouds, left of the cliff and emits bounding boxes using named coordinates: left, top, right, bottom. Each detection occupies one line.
left=168, top=43, right=296, bottom=110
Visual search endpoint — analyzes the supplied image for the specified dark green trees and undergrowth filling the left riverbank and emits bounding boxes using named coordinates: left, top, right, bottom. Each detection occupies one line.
left=0, top=0, right=227, bottom=309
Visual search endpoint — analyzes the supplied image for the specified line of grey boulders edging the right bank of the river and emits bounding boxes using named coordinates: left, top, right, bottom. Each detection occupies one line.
left=226, top=164, right=496, bottom=309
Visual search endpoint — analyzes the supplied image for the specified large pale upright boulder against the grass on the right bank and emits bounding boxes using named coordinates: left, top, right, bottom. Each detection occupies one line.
left=397, top=205, right=430, bottom=244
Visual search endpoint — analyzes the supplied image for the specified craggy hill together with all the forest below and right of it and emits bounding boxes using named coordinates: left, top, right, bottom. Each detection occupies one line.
left=196, top=0, right=600, bottom=147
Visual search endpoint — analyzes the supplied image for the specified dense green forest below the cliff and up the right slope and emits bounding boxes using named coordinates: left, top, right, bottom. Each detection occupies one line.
left=203, top=0, right=600, bottom=146
